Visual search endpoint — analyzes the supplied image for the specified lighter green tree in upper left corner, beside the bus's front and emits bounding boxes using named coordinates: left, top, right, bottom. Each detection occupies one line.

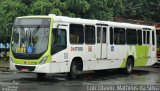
left=0, top=0, right=27, bottom=42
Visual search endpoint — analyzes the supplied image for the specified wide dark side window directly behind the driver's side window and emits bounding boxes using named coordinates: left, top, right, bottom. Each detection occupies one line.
left=69, top=24, right=84, bottom=44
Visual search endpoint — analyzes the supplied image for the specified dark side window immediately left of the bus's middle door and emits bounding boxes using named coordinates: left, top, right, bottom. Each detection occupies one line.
left=85, top=25, right=95, bottom=44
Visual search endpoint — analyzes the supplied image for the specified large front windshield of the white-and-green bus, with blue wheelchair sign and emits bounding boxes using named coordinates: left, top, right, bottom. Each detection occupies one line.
left=11, top=19, right=50, bottom=54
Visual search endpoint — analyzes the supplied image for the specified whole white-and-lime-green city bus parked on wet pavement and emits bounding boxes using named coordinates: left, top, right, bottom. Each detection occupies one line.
left=10, top=14, right=157, bottom=79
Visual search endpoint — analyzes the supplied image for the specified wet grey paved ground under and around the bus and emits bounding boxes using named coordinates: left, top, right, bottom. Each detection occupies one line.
left=0, top=67, right=160, bottom=91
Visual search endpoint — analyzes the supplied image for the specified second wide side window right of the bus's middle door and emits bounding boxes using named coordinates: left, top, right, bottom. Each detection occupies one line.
left=126, top=29, right=137, bottom=44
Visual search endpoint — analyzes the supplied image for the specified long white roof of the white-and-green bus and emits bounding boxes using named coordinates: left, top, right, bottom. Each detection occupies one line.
left=18, top=14, right=155, bottom=30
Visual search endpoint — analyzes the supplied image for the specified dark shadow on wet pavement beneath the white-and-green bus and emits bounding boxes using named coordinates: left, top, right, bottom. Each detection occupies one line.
left=3, top=69, right=149, bottom=85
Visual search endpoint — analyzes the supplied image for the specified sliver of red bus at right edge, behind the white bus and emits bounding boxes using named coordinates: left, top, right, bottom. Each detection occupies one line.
left=156, top=29, right=160, bottom=63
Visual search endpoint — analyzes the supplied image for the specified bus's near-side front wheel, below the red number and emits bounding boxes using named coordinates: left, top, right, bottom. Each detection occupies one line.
left=67, top=61, right=79, bottom=80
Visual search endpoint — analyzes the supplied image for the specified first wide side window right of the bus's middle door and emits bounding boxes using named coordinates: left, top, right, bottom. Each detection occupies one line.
left=114, top=28, right=125, bottom=44
